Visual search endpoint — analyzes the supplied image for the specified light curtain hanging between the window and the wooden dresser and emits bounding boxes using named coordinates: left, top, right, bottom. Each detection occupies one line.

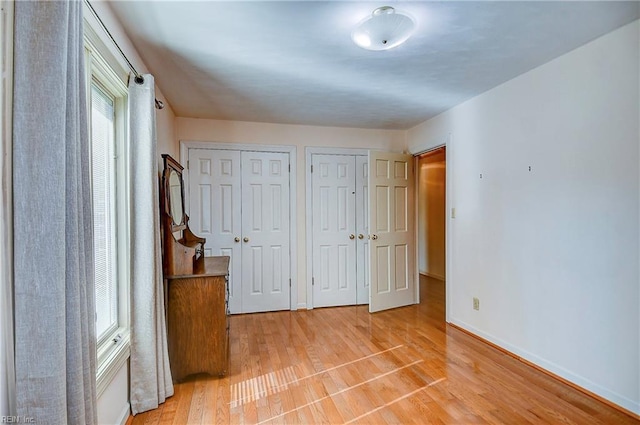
left=129, top=74, right=173, bottom=415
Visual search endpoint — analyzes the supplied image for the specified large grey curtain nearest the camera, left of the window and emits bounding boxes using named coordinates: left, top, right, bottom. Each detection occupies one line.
left=13, top=1, right=97, bottom=425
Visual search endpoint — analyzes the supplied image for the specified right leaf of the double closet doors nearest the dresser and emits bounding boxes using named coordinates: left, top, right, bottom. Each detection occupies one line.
left=241, top=151, right=291, bottom=313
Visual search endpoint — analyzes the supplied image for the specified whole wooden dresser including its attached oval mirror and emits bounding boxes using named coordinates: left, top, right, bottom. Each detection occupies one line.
left=160, top=154, right=229, bottom=382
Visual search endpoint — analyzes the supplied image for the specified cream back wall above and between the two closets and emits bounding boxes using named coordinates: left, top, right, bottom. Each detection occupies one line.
left=176, top=117, right=406, bottom=308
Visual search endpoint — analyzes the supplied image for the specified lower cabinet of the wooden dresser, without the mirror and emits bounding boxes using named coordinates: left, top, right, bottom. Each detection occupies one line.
left=166, top=257, right=229, bottom=382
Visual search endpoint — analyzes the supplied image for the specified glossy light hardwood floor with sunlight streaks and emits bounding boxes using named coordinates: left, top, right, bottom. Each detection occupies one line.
left=130, top=276, right=640, bottom=425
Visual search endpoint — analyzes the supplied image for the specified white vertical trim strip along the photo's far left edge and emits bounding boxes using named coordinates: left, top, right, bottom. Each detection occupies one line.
left=0, top=0, right=16, bottom=415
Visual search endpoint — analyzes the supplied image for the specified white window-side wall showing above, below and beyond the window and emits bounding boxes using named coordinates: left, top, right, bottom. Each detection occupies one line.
left=85, top=1, right=177, bottom=425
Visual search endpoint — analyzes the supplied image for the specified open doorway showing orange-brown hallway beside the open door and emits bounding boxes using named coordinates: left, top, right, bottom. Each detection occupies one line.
left=417, top=147, right=447, bottom=308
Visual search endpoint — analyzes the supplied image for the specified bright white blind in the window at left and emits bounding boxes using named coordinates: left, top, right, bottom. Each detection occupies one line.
left=91, top=82, right=118, bottom=341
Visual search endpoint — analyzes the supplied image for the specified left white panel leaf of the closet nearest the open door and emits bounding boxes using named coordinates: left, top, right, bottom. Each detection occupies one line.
left=311, top=154, right=357, bottom=307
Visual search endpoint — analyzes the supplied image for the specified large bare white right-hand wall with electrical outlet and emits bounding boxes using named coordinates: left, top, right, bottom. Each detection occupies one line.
left=407, top=21, right=640, bottom=413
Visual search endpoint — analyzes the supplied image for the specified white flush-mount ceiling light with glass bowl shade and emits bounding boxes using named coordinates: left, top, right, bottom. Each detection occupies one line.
left=351, top=6, right=416, bottom=50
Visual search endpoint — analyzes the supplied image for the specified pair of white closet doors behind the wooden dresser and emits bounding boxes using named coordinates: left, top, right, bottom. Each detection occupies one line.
left=189, top=149, right=291, bottom=313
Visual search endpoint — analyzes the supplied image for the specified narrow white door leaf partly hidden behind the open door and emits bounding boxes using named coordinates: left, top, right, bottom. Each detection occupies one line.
left=355, top=155, right=369, bottom=304
